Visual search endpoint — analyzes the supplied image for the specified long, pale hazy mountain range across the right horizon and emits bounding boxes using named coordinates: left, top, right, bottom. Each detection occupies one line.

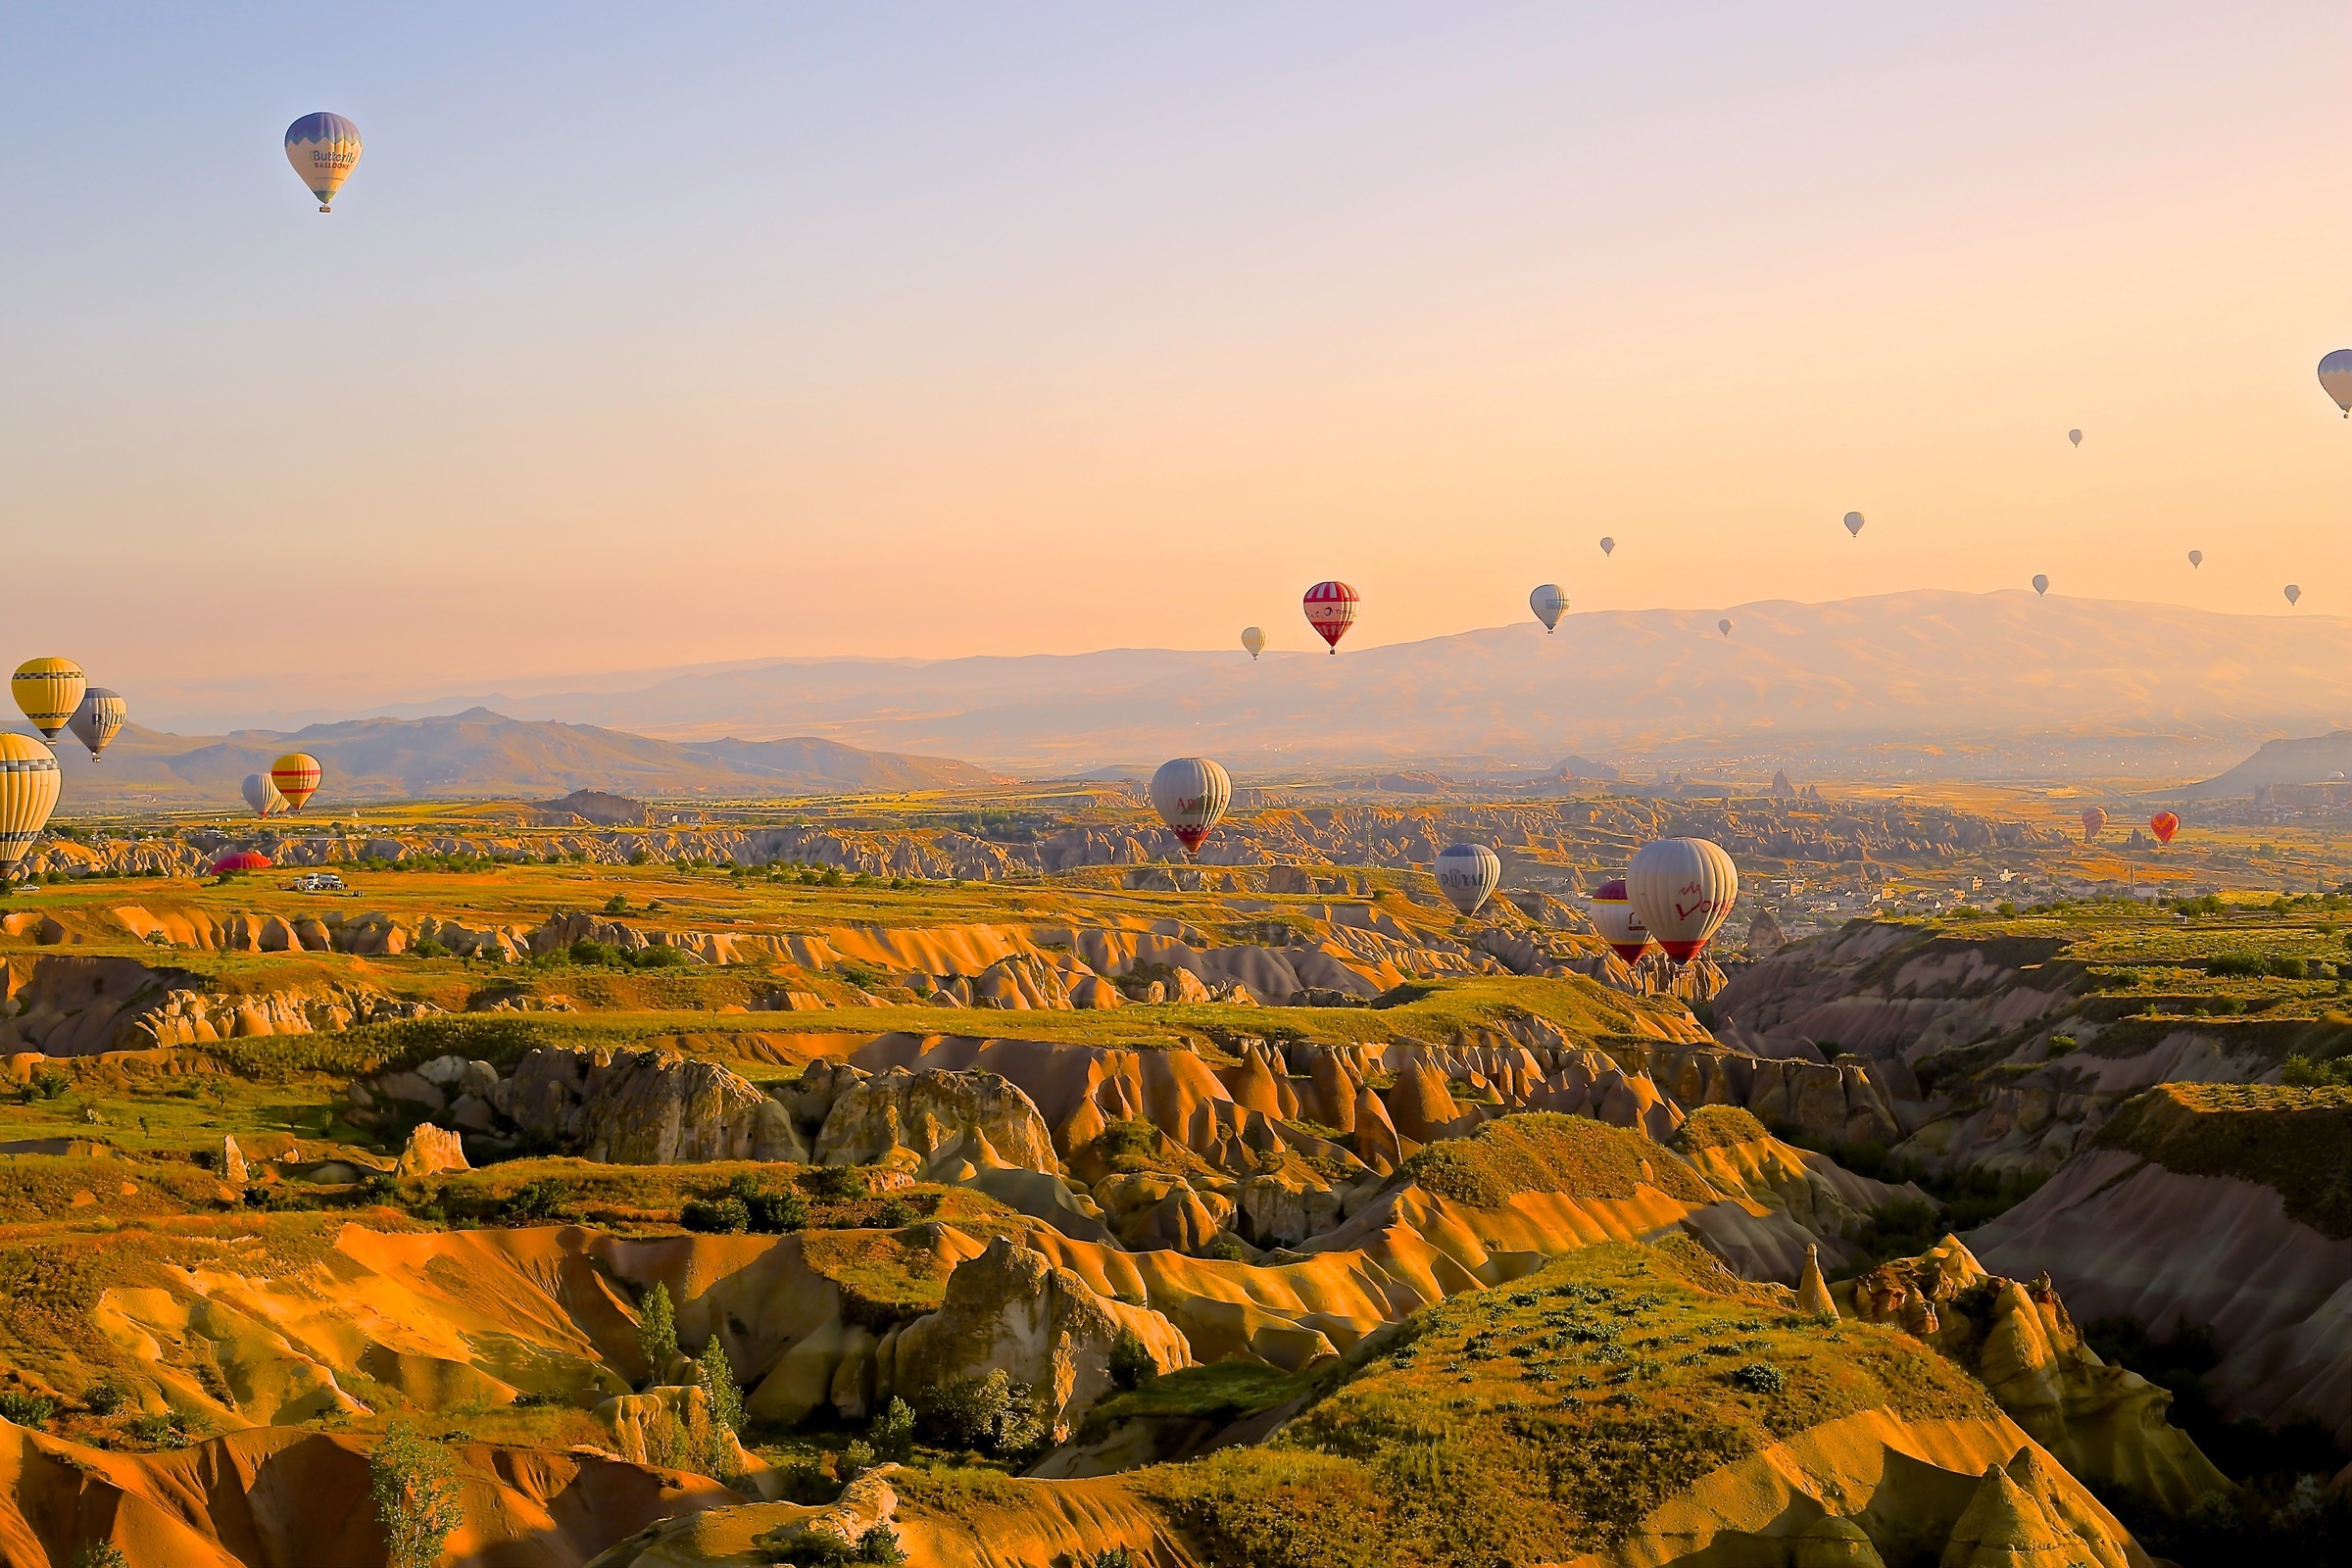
left=321, top=590, right=2352, bottom=776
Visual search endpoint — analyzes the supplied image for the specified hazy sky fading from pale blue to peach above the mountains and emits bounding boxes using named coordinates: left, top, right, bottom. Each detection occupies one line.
left=0, top=0, right=2352, bottom=696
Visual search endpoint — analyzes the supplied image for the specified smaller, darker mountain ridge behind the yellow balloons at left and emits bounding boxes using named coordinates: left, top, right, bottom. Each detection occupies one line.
left=57, top=708, right=998, bottom=813
